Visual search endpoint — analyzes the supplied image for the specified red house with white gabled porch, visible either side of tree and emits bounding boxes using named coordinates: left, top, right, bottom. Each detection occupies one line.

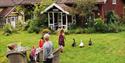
left=42, top=0, right=124, bottom=30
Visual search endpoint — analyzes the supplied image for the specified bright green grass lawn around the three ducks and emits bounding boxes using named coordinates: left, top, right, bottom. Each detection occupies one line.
left=0, top=32, right=125, bottom=63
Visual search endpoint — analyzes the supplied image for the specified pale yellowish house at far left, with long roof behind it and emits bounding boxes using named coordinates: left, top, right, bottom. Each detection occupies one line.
left=0, top=0, right=41, bottom=28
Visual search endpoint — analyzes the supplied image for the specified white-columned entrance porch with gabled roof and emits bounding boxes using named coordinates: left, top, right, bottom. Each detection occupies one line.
left=42, top=3, right=76, bottom=30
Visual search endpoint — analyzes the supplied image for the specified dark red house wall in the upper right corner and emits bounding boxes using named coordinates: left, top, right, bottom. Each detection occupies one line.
left=97, top=0, right=124, bottom=18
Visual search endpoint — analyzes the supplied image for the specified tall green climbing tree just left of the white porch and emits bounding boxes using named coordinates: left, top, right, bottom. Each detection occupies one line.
left=28, top=0, right=54, bottom=33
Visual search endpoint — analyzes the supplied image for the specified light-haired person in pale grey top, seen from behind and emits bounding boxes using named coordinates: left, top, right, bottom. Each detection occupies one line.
left=43, top=34, right=53, bottom=63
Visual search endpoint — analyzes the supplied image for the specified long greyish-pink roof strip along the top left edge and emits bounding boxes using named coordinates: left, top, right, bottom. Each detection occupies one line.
left=0, top=0, right=42, bottom=7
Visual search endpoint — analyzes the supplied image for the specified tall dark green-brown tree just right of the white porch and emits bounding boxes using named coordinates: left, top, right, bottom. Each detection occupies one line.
left=75, top=0, right=96, bottom=25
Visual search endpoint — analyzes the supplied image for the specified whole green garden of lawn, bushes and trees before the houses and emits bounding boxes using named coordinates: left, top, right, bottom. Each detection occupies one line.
left=0, top=0, right=125, bottom=63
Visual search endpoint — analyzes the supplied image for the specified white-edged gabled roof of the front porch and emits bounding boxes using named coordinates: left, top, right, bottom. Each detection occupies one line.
left=41, top=3, right=74, bottom=14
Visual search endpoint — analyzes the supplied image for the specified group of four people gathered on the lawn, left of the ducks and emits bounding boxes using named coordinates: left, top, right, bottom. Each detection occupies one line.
left=30, top=29, right=65, bottom=63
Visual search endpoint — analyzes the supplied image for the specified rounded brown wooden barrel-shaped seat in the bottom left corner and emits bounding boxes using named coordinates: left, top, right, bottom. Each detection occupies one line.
left=7, top=52, right=28, bottom=63
